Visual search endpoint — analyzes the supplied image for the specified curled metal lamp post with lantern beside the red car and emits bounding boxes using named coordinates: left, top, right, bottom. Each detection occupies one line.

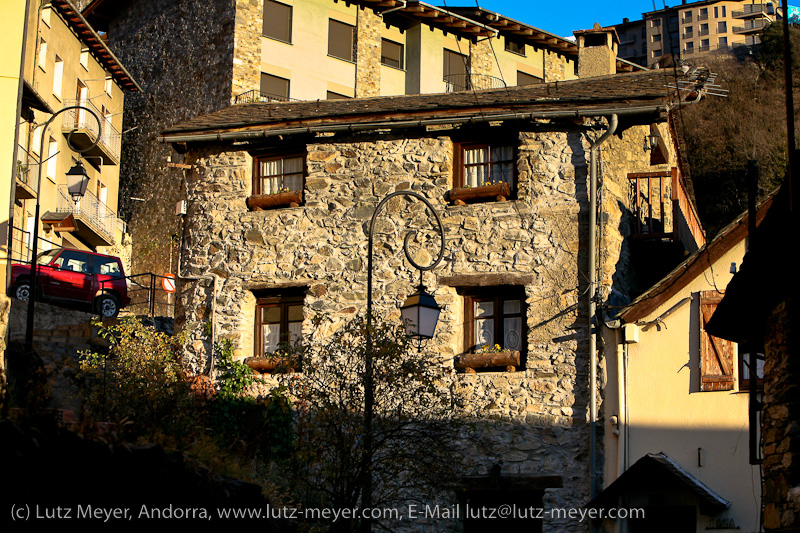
left=25, top=105, right=103, bottom=353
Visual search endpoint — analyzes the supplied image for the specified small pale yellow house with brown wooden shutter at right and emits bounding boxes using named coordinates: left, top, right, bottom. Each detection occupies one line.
left=593, top=197, right=773, bottom=532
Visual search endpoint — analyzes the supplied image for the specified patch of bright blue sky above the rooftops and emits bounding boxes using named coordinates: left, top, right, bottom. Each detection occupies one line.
left=454, top=0, right=664, bottom=37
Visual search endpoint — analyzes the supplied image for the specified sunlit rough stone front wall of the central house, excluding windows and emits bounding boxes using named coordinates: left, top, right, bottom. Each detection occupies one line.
left=179, top=115, right=676, bottom=531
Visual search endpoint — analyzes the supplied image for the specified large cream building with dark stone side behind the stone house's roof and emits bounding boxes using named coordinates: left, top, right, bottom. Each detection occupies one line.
left=76, top=0, right=644, bottom=270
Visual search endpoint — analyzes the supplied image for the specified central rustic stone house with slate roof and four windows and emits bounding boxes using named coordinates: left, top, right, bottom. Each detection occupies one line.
left=159, top=67, right=702, bottom=531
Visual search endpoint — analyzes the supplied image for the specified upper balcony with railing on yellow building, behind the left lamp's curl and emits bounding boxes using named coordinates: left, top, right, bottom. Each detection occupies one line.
left=61, top=100, right=122, bottom=164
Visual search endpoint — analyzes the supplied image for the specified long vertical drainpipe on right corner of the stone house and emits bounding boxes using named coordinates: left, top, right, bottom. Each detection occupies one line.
left=589, top=114, right=617, bottom=498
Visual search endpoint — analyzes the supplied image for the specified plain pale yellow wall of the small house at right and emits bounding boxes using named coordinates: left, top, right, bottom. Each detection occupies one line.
left=603, top=241, right=760, bottom=533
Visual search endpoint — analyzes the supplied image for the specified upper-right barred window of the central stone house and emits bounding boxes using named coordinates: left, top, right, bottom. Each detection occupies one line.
left=454, top=141, right=516, bottom=192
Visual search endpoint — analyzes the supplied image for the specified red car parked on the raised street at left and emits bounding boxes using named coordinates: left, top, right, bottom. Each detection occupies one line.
left=9, top=248, right=131, bottom=318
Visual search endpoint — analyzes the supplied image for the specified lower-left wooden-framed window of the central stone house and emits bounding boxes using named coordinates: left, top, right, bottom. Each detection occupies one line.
left=254, top=290, right=304, bottom=357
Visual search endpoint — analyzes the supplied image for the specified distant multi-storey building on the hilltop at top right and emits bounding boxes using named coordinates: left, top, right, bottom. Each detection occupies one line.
left=614, top=0, right=780, bottom=67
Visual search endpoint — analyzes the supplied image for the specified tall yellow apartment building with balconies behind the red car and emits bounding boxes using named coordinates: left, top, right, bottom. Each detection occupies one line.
left=0, top=0, right=139, bottom=290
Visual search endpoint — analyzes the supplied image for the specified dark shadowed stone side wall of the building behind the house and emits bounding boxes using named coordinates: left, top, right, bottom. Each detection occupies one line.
left=101, top=0, right=238, bottom=274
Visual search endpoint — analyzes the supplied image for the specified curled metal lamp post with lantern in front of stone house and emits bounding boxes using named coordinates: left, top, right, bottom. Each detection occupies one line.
left=361, top=191, right=445, bottom=531
